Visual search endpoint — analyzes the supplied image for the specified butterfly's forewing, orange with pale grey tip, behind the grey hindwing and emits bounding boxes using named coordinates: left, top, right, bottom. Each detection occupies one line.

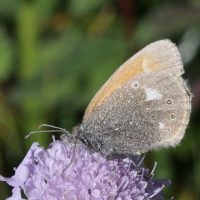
left=84, top=40, right=184, bottom=119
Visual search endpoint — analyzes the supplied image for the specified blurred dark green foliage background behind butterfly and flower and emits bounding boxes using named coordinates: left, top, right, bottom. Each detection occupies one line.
left=0, top=0, right=200, bottom=200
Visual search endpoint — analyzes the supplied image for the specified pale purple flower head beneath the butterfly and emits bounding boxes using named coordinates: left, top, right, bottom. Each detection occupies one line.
left=0, top=138, right=171, bottom=200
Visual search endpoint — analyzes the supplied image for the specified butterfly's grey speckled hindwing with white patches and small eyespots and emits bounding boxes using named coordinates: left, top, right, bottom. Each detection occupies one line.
left=82, top=70, right=191, bottom=154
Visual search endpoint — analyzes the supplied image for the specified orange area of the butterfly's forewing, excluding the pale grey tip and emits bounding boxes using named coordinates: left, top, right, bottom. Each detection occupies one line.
left=84, top=54, right=163, bottom=119
